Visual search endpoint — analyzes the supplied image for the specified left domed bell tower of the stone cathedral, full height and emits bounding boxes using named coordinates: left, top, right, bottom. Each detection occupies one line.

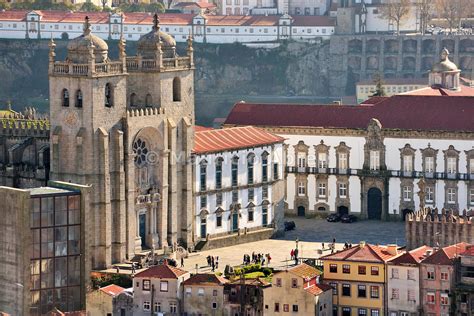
left=49, top=17, right=127, bottom=268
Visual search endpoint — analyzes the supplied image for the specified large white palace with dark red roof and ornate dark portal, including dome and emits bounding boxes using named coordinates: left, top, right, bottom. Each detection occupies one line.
left=224, top=49, right=474, bottom=220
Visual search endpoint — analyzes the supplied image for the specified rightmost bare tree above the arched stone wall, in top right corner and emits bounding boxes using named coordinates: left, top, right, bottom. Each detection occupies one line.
left=435, top=0, right=472, bottom=33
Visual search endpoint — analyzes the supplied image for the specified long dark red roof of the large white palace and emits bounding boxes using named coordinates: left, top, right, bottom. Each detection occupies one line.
left=224, top=93, right=474, bottom=132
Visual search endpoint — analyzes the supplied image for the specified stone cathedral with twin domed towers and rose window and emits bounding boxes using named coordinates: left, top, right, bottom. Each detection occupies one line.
left=49, top=15, right=194, bottom=268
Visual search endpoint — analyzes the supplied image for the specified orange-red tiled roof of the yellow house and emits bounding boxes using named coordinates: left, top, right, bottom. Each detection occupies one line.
left=321, top=244, right=399, bottom=263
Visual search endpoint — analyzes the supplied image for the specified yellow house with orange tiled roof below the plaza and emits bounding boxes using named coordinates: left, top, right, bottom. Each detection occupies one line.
left=321, top=242, right=398, bottom=316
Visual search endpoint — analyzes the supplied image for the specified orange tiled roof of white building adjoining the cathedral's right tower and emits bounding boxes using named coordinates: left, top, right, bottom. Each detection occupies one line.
left=193, top=126, right=284, bottom=154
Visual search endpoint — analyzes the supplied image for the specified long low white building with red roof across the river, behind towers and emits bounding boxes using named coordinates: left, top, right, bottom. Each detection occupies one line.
left=0, top=10, right=335, bottom=44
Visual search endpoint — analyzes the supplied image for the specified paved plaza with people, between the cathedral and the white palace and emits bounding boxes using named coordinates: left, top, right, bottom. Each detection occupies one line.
left=107, top=217, right=405, bottom=273
